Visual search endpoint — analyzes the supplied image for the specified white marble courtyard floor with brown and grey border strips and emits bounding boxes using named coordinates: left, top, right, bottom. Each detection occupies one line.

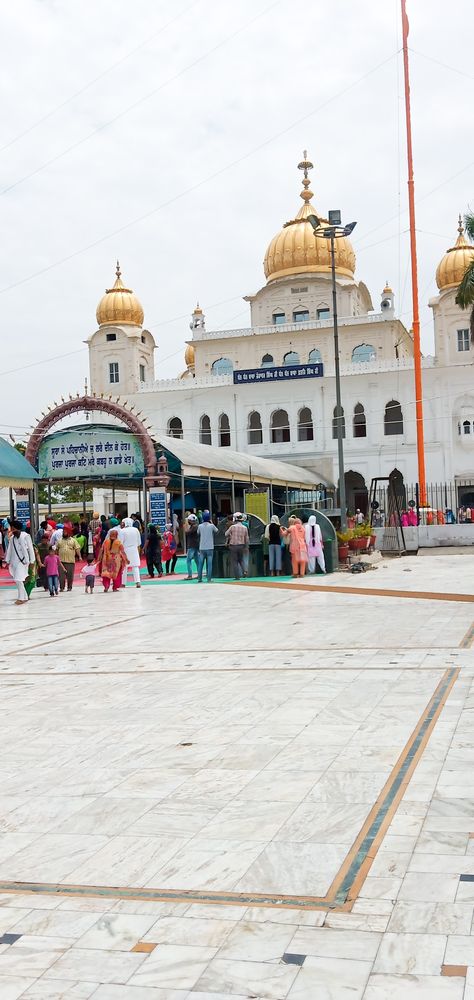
left=0, top=555, right=474, bottom=1000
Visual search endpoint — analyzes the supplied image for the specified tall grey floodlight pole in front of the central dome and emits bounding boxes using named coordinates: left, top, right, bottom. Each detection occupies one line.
left=307, top=210, right=356, bottom=531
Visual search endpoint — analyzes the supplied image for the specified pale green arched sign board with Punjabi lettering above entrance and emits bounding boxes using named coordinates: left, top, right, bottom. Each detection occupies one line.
left=38, top=424, right=145, bottom=479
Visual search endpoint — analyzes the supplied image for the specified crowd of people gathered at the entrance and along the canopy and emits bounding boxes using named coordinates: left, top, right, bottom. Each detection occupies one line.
left=0, top=510, right=326, bottom=605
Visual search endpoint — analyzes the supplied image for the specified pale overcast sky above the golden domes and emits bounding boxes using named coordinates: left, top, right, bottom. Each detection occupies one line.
left=0, top=0, right=474, bottom=437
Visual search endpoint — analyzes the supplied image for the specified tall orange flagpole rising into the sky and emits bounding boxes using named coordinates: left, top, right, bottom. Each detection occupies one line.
left=401, top=0, right=426, bottom=506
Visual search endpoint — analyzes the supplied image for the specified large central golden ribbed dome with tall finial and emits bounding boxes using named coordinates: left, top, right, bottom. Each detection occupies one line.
left=263, top=150, right=355, bottom=282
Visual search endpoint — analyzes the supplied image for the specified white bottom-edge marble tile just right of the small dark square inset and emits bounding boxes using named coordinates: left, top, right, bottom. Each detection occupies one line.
left=288, top=955, right=371, bottom=1000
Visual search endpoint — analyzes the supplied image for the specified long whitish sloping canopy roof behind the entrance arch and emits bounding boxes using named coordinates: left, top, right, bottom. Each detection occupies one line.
left=150, top=429, right=329, bottom=489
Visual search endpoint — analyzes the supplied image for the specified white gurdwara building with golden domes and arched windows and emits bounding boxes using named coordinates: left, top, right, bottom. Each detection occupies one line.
left=88, top=154, right=474, bottom=507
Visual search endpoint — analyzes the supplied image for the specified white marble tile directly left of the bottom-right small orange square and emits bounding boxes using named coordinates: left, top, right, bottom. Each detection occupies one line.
left=373, top=933, right=446, bottom=976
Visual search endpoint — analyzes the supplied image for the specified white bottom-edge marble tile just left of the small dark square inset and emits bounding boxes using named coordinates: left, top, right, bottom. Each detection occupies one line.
left=192, top=958, right=298, bottom=1000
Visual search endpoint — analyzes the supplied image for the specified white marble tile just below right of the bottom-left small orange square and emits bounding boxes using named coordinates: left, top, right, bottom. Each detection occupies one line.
left=129, top=944, right=216, bottom=990
